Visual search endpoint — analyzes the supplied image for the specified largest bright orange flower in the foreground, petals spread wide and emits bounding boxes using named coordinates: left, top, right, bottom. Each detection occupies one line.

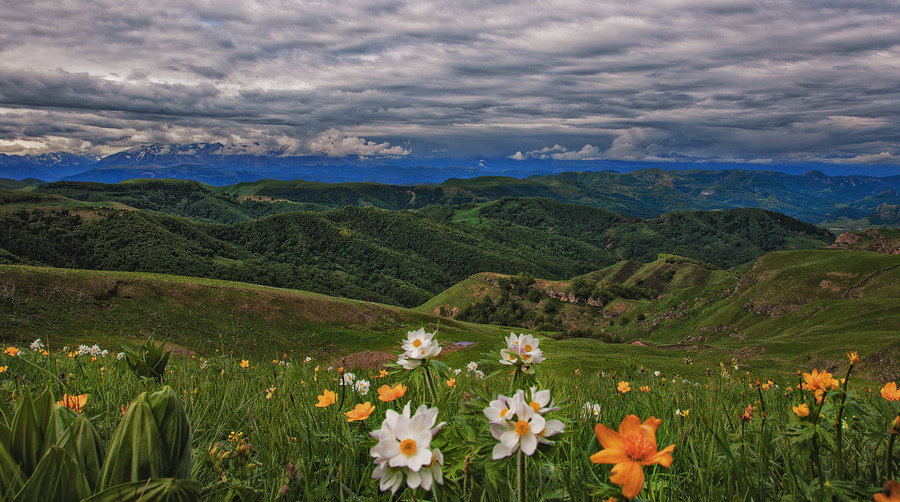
left=591, top=415, right=675, bottom=499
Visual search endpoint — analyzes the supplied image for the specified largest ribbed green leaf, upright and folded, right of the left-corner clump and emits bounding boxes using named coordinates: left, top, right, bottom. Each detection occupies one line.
left=97, top=386, right=191, bottom=490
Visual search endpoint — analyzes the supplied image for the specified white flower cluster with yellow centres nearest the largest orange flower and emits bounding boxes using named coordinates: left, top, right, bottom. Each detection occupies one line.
left=484, top=387, right=565, bottom=460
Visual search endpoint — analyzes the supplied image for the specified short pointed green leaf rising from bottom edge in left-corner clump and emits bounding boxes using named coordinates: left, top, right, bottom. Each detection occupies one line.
left=13, top=446, right=91, bottom=502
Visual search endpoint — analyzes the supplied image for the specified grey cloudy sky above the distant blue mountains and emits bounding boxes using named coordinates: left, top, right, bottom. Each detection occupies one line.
left=0, top=0, right=900, bottom=165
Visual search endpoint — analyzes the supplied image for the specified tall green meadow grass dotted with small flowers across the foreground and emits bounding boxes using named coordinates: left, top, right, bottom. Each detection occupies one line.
left=0, top=340, right=900, bottom=501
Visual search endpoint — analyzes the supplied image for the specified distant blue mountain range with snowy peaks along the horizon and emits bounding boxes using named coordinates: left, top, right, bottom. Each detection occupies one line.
left=0, top=143, right=898, bottom=186
